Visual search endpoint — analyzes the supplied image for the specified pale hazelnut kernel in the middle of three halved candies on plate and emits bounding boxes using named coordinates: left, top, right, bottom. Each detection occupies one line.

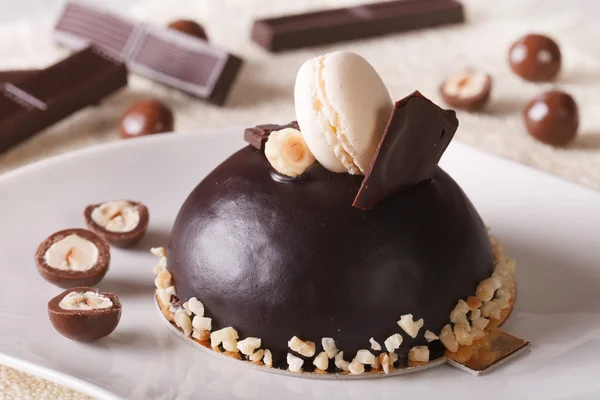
left=44, top=234, right=98, bottom=271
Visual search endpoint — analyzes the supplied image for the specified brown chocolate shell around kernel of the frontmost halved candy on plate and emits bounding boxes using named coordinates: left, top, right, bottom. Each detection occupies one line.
left=48, top=287, right=121, bottom=343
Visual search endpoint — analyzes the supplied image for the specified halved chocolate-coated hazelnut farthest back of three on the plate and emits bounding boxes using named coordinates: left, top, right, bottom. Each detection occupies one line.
left=83, top=200, right=150, bottom=247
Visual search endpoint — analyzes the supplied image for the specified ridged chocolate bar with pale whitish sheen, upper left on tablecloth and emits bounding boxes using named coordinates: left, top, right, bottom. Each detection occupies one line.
left=54, top=2, right=242, bottom=105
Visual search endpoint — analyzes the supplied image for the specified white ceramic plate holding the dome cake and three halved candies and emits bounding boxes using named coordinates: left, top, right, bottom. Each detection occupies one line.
left=0, top=129, right=600, bottom=400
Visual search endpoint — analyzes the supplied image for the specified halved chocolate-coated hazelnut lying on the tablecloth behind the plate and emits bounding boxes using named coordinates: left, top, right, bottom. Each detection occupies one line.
left=440, top=69, right=492, bottom=111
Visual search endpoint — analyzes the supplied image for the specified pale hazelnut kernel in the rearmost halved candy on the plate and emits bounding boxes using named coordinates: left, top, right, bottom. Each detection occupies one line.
left=91, top=200, right=140, bottom=232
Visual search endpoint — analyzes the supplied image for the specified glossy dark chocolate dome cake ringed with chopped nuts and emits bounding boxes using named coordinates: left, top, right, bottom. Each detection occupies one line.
left=153, top=53, right=514, bottom=374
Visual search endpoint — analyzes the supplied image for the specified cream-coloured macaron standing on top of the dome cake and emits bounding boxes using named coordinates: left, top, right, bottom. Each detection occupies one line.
left=294, top=51, right=393, bottom=175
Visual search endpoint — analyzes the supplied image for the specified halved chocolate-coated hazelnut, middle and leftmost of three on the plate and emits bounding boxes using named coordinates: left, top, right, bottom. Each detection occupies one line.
left=35, top=229, right=110, bottom=288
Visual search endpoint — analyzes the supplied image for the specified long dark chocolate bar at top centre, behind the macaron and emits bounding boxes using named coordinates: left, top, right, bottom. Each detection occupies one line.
left=252, top=0, right=464, bottom=52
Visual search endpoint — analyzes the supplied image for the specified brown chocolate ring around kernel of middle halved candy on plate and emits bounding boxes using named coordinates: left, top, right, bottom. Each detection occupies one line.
left=35, top=228, right=110, bottom=288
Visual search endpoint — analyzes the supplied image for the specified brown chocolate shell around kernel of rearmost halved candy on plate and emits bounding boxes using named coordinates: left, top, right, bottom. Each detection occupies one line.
left=83, top=200, right=150, bottom=248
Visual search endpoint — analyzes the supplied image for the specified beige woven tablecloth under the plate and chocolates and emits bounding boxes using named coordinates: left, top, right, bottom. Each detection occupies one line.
left=0, top=0, right=600, bottom=399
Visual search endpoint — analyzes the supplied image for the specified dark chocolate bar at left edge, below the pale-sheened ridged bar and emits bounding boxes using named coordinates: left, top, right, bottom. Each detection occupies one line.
left=0, top=48, right=127, bottom=152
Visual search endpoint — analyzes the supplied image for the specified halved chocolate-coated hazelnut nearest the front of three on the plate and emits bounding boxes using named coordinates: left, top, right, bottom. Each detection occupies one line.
left=48, top=287, right=121, bottom=343
